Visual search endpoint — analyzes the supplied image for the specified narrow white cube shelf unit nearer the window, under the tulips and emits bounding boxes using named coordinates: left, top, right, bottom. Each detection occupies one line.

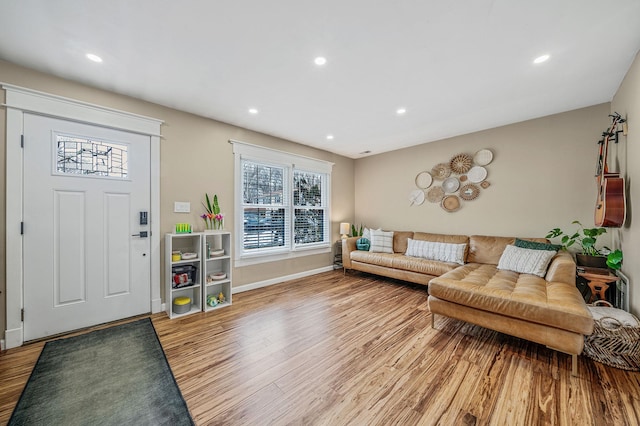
left=202, top=231, right=232, bottom=312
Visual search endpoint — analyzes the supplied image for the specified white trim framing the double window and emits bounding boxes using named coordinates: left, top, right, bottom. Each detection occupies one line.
left=229, top=139, right=334, bottom=267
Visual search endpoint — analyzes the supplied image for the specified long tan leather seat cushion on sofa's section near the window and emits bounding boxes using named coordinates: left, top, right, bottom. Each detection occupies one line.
left=351, top=251, right=460, bottom=276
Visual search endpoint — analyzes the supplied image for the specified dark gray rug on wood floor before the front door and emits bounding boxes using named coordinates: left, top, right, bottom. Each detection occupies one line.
left=9, top=318, right=193, bottom=426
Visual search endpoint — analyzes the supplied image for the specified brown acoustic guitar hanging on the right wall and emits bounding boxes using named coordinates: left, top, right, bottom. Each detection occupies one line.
left=594, top=112, right=626, bottom=228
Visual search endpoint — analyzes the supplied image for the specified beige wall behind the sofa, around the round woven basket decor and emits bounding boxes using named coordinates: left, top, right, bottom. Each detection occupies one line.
left=355, top=104, right=609, bottom=237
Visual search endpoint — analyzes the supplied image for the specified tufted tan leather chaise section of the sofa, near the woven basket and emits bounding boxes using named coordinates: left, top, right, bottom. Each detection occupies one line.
left=428, top=236, right=593, bottom=375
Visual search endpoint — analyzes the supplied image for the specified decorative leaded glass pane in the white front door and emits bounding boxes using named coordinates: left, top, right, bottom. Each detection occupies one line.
left=56, top=135, right=129, bottom=179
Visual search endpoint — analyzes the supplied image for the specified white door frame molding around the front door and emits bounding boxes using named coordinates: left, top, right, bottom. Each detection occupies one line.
left=0, top=83, right=163, bottom=349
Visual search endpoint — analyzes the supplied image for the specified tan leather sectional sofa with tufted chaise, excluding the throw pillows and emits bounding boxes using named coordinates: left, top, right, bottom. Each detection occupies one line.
left=342, top=231, right=593, bottom=375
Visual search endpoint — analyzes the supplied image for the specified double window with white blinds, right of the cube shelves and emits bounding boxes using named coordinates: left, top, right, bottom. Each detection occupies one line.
left=232, top=141, right=332, bottom=260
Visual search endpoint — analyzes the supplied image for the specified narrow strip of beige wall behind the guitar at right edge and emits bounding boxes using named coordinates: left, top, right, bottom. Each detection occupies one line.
left=611, top=50, right=640, bottom=316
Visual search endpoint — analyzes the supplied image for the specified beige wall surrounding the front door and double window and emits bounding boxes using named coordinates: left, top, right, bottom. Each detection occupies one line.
left=0, top=61, right=354, bottom=340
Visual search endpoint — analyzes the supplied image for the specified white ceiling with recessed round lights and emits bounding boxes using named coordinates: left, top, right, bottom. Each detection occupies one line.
left=0, top=0, right=640, bottom=158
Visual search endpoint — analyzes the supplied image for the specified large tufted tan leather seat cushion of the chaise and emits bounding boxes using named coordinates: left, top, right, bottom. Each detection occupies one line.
left=429, top=263, right=593, bottom=335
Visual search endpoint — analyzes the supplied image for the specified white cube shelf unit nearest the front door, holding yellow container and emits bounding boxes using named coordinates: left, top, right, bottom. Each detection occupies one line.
left=164, top=233, right=202, bottom=318
